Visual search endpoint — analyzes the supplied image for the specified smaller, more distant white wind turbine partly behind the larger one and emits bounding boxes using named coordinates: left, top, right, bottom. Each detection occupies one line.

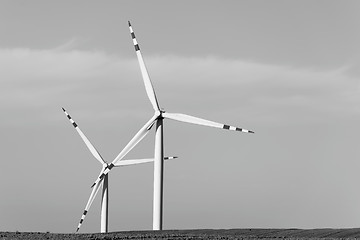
left=62, top=108, right=177, bottom=233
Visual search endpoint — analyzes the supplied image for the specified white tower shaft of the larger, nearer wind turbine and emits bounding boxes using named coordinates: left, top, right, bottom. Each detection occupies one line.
left=153, top=117, right=164, bottom=230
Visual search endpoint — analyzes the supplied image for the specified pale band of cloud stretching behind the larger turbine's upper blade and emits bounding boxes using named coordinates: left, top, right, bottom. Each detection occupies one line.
left=0, top=43, right=359, bottom=126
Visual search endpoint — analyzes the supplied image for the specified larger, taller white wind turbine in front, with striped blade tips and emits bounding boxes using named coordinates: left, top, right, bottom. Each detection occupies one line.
left=89, top=22, right=254, bottom=230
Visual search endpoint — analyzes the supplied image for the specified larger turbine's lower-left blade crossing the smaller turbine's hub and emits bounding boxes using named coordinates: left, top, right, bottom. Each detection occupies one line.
left=91, top=112, right=159, bottom=187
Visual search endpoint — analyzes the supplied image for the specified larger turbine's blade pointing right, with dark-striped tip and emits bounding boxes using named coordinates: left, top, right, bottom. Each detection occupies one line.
left=162, top=112, right=254, bottom=133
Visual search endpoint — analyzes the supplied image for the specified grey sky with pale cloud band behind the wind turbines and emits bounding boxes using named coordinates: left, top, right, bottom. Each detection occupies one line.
left=0, top=0, right=360, bottom=233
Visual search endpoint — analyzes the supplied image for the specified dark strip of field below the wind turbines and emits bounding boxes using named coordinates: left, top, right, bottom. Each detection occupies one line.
left=0, top=228, right=360, bottom=240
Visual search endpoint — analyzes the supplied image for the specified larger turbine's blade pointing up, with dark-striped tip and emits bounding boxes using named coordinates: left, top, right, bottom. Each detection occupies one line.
left=128, top=21, right=160, bottom=111
